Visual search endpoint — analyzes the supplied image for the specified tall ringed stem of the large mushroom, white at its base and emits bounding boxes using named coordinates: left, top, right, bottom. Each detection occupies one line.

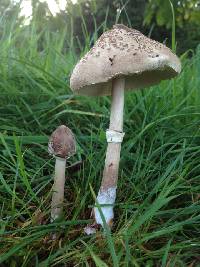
left=94, top=77, right=125, bottom=226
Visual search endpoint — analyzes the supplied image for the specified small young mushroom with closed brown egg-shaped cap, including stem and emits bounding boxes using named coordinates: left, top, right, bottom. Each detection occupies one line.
left=48, top=125, right=76, bottom=222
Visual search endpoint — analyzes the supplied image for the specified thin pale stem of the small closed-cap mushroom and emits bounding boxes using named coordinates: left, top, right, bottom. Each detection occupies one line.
left=51, top=157, right=66, bottom=222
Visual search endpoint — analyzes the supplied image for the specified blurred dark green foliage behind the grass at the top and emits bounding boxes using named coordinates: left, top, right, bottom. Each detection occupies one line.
left=0, top=0, right=200, bottom=53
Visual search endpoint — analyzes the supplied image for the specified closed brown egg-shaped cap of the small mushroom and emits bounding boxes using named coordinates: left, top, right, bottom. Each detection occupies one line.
left=48, top=125, right=76, bottom=158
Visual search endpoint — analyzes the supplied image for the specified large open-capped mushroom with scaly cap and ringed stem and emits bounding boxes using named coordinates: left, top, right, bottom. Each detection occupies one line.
left=70, top=24, right=181, bottom=234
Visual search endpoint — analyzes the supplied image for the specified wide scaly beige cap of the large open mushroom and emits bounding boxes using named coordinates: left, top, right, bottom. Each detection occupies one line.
left=70, top=24, right=181, bottom=96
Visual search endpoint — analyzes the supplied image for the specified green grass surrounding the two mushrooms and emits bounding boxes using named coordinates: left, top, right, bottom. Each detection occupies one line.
left=0, top=6, right=200, bottom=267
